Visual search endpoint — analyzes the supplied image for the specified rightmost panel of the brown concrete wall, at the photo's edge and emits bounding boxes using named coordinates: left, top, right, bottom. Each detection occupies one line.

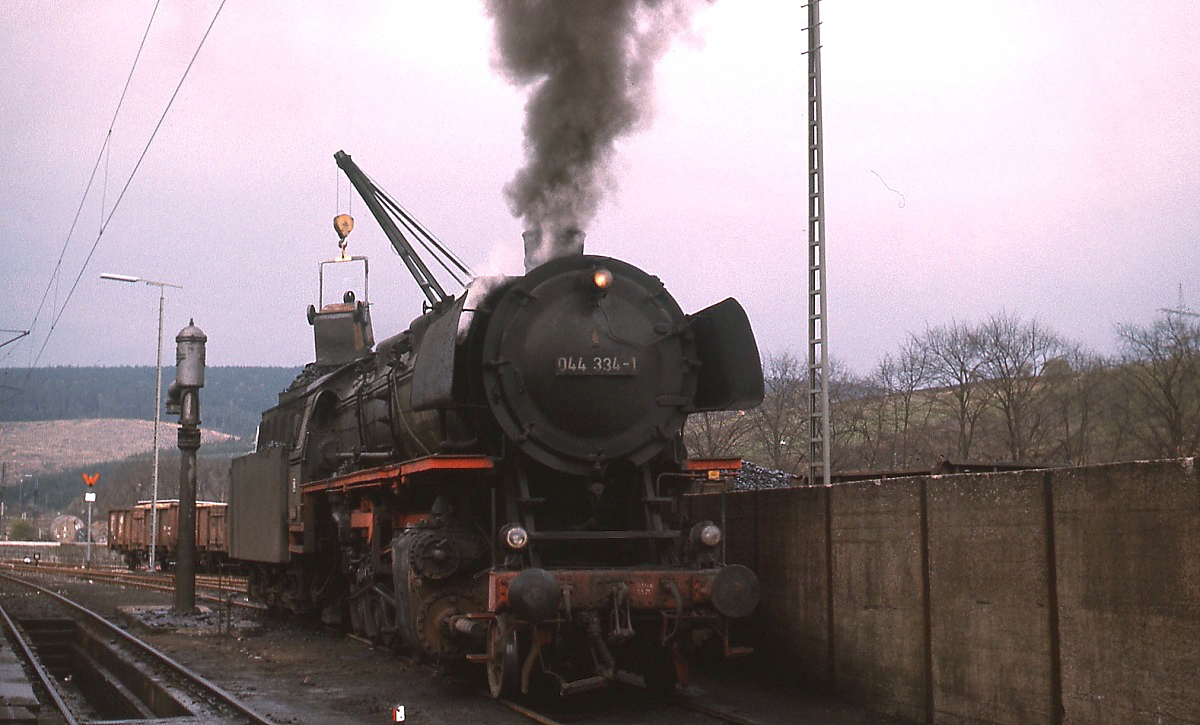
left=1054, top=459, right=1200, bottom=723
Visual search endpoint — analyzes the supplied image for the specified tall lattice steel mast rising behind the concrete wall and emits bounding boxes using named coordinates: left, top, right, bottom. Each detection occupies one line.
left=808, top=0, right=829, bottom=484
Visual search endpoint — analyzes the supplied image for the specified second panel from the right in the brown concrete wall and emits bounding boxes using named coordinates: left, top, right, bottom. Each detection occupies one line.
left=925, top=472, right=1057, bottom=723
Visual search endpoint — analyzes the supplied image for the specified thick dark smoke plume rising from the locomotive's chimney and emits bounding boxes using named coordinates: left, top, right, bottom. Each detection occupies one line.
left=487, top=0, right=695, bottom=270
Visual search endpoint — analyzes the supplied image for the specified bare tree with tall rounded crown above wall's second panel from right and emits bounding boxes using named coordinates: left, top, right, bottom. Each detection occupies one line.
left=979, top=312, right=1064, bottom=461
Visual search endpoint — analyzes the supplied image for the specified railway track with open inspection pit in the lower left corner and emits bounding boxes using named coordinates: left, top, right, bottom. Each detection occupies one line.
left=0, top=574, right=271, bottom=724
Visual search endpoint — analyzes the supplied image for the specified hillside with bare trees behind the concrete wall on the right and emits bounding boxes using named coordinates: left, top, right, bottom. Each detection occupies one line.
left=685, top=312, right=1200, bottom=474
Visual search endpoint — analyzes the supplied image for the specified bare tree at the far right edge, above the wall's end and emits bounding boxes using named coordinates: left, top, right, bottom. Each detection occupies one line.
left=1117, top=314, right=1200, bottom=456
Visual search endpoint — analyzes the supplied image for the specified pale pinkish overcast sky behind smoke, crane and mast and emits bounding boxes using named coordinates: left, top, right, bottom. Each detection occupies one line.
left=0, top=0, right=1200, bottom=372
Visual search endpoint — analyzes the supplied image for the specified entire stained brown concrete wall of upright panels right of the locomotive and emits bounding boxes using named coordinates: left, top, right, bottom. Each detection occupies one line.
left=689, top=459, right=1200, bottom=724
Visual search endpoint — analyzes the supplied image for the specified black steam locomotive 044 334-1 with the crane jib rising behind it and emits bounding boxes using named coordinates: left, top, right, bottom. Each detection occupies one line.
left=228, top=152, right=763, bottom=696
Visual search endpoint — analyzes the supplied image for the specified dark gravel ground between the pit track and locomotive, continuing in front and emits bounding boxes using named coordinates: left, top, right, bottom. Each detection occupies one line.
left=4, top=577, right=896, bottom=725
